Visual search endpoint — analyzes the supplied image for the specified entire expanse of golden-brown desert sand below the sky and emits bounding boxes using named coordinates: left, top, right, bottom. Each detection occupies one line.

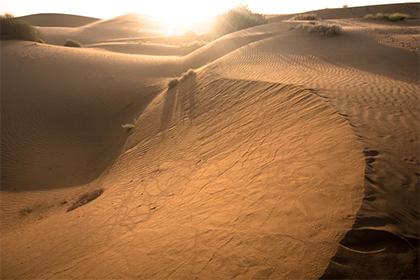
left=0, top=2, right=420, bottom=279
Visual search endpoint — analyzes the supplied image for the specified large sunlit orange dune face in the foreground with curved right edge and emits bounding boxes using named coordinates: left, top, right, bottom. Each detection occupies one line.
left=3, top=72, right=364, bottom=279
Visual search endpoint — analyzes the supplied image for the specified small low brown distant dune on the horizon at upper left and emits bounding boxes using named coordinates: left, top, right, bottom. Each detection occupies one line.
left=19, top=14, right=98, bottom=27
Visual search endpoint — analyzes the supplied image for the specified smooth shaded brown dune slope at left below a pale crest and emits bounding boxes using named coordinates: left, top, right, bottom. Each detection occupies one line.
left=1, top=42, right=179, bottom=190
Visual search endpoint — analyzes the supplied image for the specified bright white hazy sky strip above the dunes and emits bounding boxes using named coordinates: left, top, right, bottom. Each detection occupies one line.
left=0, top=0, right=418, bottom=18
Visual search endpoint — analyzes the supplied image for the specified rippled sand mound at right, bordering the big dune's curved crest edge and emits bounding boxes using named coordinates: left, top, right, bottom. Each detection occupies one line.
left=212, top=21, right=420, bottom=278
